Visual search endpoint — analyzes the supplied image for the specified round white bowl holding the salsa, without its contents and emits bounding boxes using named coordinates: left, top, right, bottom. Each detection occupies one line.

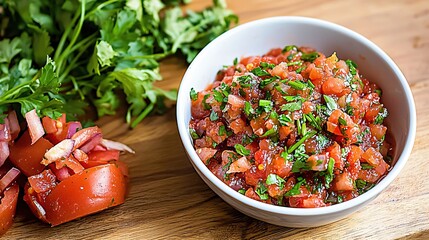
left=177, top=17, right=416, bottom=227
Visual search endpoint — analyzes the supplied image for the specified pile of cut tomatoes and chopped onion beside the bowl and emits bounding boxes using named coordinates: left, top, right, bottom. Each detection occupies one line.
left=0, top=110, right=133, bottom=236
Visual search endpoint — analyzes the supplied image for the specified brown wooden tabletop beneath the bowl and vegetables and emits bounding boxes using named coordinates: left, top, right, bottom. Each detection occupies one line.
left=4, top=0, right=429, bottom=239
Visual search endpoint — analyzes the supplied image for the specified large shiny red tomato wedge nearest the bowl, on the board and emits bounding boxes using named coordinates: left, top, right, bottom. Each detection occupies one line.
left=24, top=164, right=127, bottom=226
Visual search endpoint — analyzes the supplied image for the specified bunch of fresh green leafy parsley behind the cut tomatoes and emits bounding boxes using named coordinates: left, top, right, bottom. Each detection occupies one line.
left=0, top=0, right=237, bottom=127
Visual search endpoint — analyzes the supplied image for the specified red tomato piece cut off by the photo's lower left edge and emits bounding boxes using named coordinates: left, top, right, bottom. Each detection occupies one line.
left=0, top=184, right=19, bottom=237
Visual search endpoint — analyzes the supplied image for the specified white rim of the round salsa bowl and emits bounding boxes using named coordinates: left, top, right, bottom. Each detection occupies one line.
left=176, top=16, right=416, bottom=216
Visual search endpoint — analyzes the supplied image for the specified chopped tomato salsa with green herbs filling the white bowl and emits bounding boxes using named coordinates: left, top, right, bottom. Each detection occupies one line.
left=189, top=46, right=392, bottom=208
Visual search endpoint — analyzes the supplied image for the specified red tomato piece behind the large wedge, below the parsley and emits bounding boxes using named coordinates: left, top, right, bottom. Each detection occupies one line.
left=9, top=131, right=53, bottom=176
